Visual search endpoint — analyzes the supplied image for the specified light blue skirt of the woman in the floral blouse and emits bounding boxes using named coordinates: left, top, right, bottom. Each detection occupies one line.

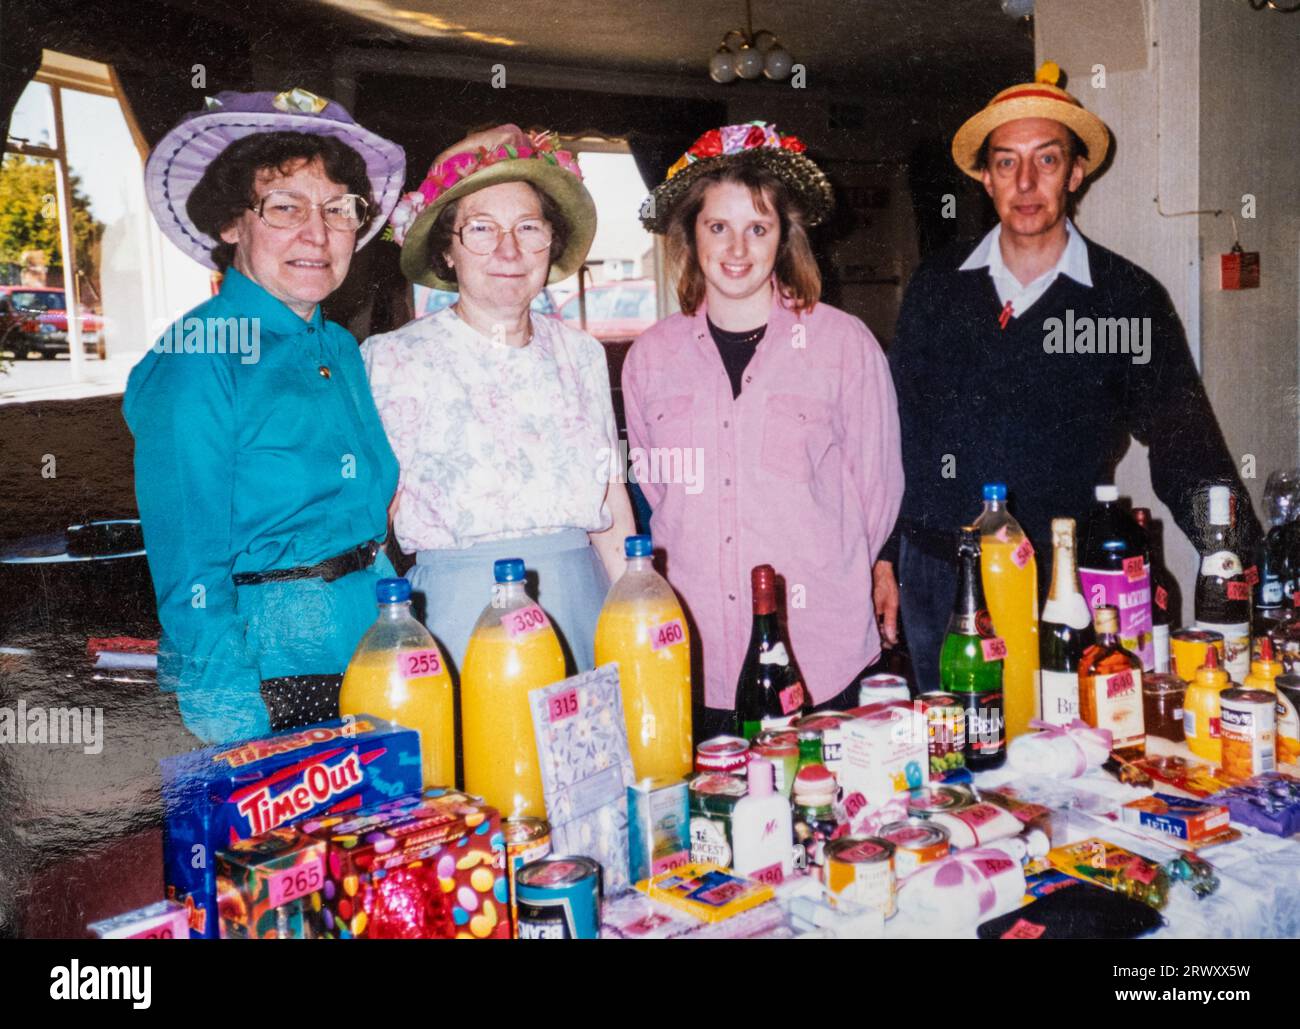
left=407, top=529, right=610, bottom=681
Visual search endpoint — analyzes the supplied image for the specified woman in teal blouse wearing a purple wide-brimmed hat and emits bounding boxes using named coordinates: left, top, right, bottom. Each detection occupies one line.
left=122, top=90, right=406, bottom=743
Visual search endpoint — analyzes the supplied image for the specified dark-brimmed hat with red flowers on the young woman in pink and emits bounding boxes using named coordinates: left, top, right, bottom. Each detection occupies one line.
left=641, top=121, right=835, bottom=234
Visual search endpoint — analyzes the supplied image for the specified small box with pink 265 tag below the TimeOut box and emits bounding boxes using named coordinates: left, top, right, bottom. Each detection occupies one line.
left=217, top=826, right=325, bottom=939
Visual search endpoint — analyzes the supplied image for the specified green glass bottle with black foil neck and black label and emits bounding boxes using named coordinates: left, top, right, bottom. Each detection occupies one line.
left=939, top=525, right=1006, bottom=772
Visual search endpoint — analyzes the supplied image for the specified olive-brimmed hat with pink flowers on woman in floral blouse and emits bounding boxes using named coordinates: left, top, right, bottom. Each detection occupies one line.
left=387, top=125, right=595, bottom=291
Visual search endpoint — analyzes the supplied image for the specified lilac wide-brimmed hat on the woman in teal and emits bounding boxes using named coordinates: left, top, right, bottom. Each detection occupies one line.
left=144, top=90, right=406, bottom=268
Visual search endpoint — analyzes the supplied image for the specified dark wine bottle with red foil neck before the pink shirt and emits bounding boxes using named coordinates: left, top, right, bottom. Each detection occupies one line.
left=736, top=565, right=813, bottom=742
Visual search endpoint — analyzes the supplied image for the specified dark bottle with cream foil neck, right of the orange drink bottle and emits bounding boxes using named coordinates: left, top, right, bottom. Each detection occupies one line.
left=1039, top=518, right=1095, bottom=725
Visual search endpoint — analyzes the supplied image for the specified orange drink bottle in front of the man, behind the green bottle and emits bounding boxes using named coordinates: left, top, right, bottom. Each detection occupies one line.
left=975, top=482, right=1039, bottom=742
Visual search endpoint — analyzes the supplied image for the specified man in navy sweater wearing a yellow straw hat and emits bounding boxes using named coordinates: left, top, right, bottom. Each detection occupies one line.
left=875, top=62, right=1258, bottom=690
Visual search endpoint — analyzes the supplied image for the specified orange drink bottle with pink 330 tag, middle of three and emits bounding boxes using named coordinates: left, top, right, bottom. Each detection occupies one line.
left=460, top=557, right=564, bottom=819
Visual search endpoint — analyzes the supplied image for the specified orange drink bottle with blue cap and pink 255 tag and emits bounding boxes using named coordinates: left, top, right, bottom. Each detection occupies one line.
left=338, top=578, right=456, bottom=787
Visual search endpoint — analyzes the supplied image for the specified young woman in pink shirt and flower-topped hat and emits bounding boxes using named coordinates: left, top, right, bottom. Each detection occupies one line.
left=623, top=122, right=902, bottom=739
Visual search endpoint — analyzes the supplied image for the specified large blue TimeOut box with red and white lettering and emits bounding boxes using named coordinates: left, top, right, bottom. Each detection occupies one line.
left=161, top=715, right=421, bottom=939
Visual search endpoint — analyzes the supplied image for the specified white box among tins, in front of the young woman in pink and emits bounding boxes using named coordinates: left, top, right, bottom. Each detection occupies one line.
left=839, top=700, right=930, bottom=807
